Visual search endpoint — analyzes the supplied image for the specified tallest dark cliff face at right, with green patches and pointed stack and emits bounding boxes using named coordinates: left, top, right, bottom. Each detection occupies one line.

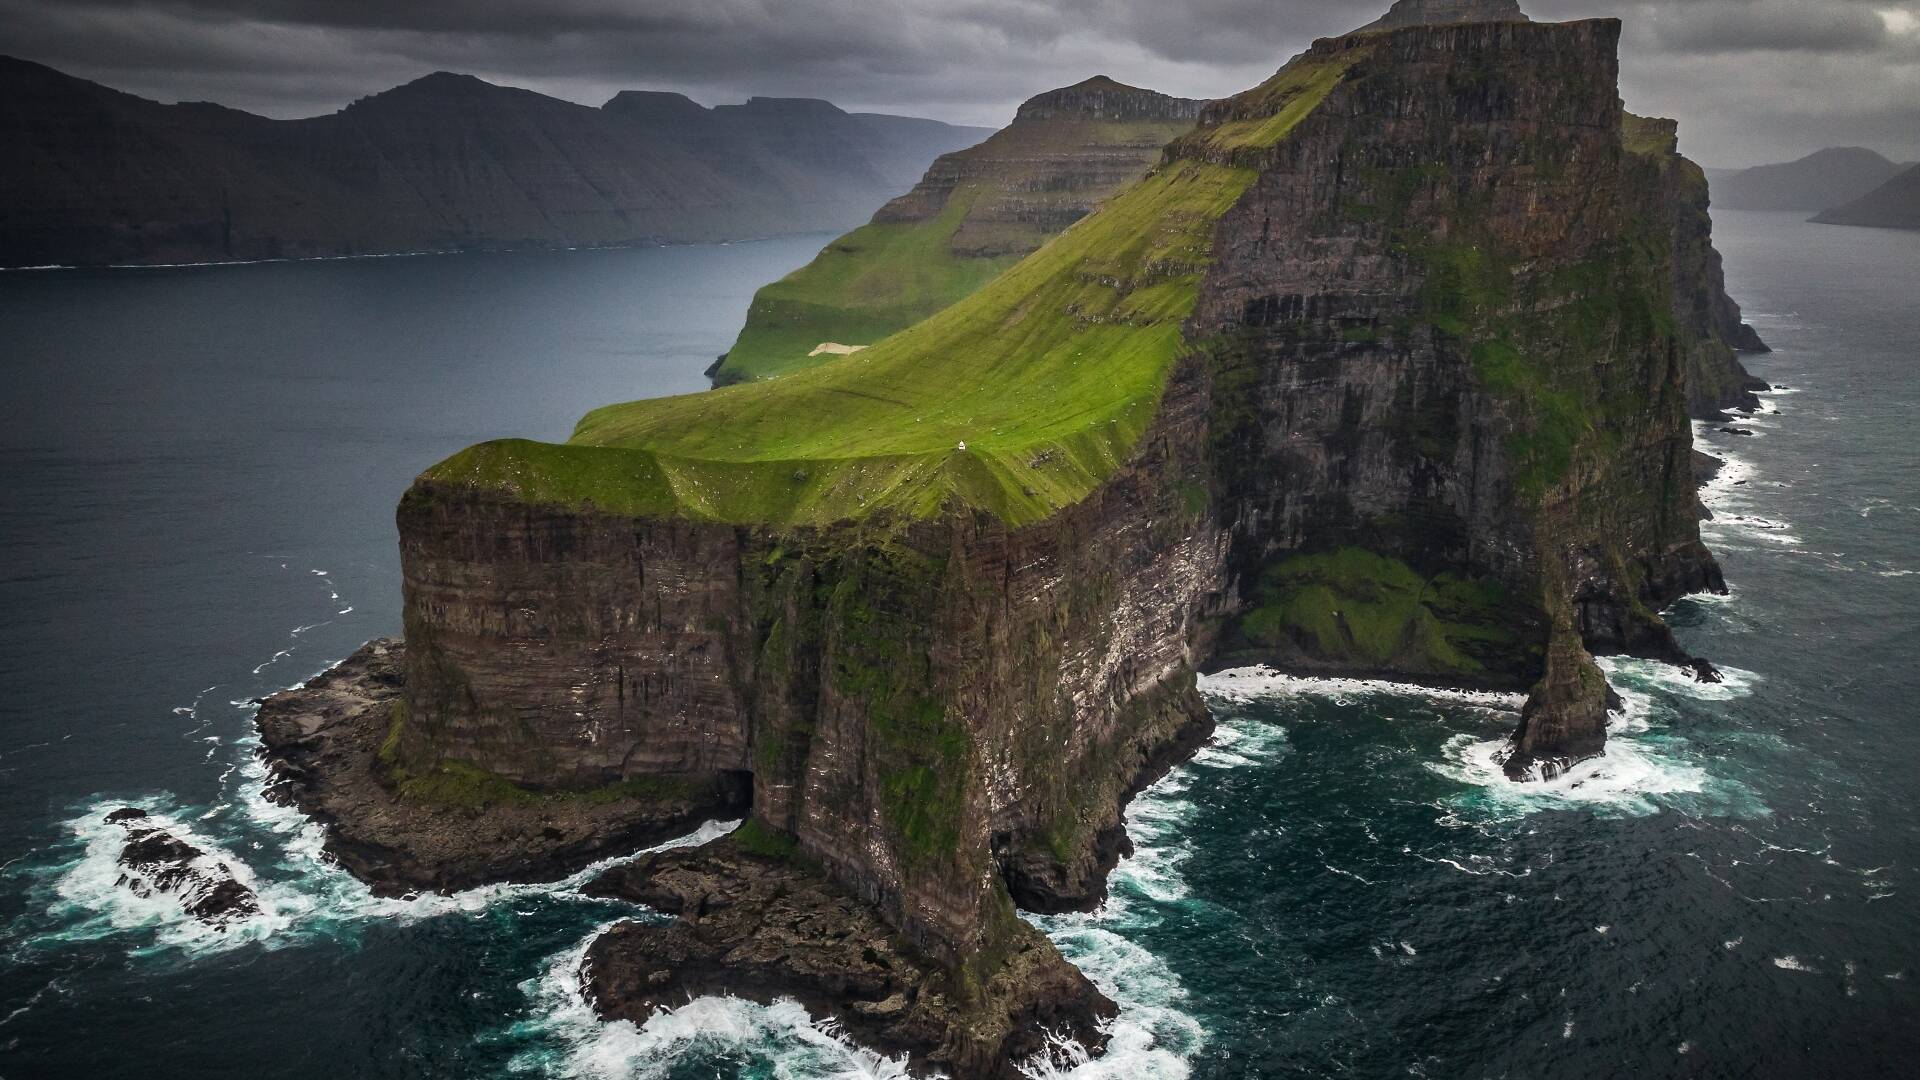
left=1190, top=21, right=1732, bottom=774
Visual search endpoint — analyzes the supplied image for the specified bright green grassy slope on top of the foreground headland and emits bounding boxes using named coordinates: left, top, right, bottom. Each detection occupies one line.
left=422, top=48, right=1365, bottom=525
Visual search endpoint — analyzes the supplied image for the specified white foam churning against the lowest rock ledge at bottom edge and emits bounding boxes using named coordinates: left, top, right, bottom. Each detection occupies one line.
left=511, top=922, right=908, bottom=1080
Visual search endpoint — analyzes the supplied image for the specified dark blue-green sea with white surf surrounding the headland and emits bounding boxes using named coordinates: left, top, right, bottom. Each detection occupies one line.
left=0, top=213, right=1920, bottom=1080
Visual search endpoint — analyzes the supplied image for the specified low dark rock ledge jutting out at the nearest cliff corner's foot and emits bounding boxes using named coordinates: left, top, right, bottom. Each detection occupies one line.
left=582, top=836, right=1116, bottom=1080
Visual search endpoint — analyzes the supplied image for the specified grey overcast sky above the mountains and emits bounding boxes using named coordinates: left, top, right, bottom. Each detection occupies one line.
left=0, top=0, right=1920, bottom=165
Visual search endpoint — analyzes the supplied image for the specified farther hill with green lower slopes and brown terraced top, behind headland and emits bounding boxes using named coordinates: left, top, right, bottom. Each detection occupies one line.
left=714, top=77, right=1200, bottom=384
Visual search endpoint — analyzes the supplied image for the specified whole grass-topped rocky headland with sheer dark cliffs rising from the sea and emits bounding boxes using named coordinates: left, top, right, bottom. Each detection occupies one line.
left=269, top=6, right=1757, bottom=1080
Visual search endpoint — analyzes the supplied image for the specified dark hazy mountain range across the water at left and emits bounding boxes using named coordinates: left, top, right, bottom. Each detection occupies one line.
left=0, top=58, right=991, bottom=265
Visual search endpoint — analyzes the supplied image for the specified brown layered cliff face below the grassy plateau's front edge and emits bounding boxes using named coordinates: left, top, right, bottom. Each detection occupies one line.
left=399, top=351, right=1225, bottom=941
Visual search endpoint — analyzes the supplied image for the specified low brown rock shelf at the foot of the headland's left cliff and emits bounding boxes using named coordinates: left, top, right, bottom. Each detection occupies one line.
left=255, top=638, right=747, bottom=896
